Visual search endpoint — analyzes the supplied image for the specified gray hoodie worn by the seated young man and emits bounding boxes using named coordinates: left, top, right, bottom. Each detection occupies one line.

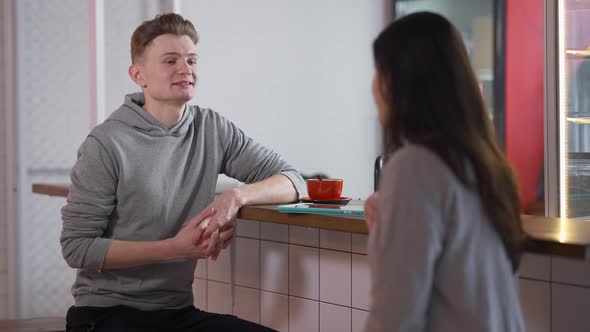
left=60, top=93, right=305, bottom=310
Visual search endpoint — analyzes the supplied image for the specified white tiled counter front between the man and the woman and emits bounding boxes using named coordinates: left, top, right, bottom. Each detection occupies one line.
left=194, top=219, right=369, bottom=332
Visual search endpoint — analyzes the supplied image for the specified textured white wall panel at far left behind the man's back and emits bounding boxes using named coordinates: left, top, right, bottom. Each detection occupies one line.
left=17, top=0, right=90, bottom=317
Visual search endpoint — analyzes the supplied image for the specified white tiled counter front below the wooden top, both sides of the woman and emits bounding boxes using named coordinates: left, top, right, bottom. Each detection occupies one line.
left=209, top=219, right=590, bottom=332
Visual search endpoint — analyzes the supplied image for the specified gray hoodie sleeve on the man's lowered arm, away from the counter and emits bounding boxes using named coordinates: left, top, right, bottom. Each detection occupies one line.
left=60, top=136, right=117, bottom=270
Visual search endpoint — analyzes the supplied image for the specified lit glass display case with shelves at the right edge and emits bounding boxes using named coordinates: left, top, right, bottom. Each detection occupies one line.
left=545, top=0, right=590, bottom=219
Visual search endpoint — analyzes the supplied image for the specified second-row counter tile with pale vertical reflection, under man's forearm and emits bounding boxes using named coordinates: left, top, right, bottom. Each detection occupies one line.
left=260, top=241, right=289, bottom=295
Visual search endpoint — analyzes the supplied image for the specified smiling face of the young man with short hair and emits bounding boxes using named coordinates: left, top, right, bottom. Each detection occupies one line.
left=129, top=34, right=198, bottom=105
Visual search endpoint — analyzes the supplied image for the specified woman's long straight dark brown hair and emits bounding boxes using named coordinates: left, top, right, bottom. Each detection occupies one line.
left=373, top=12, right=524, bottom=271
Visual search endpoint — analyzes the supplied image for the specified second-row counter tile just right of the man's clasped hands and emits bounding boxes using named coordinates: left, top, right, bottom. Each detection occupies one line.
left=235, top=237, right=260, bottom=288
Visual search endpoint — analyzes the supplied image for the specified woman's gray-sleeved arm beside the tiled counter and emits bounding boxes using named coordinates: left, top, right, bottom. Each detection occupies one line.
left=366, top=149, right=443, bottom=331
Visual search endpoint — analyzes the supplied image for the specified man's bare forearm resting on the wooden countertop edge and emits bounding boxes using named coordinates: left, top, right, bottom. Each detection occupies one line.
left=233, top=174, right=298, bottom=206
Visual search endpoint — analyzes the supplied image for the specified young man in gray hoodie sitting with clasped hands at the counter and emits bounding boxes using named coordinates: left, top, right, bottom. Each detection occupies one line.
left=60, top=14, right=305, bottom=331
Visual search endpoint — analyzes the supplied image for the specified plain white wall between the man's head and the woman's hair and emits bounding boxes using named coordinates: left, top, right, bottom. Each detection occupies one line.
left=180, top=0, right=389, bottom=198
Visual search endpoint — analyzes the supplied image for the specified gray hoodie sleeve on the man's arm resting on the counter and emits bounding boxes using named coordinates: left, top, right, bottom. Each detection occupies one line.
left=216, top=114, right=306, bottom=197
